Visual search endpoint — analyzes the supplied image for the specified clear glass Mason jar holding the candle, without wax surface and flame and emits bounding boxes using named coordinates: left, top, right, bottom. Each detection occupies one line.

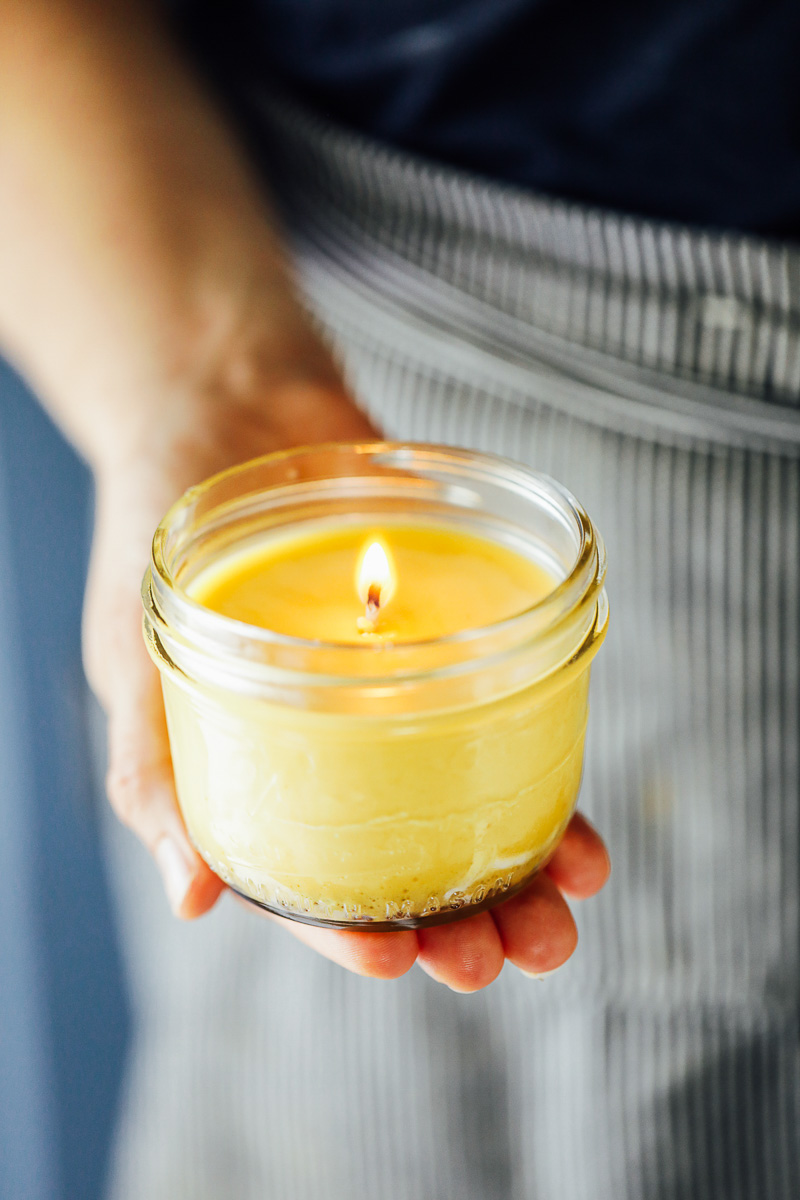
left=143, top=443, right=608, bottom=929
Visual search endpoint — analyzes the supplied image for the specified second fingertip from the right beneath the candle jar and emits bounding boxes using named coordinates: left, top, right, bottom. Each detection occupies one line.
left=492, top=874, right=578, bottom=974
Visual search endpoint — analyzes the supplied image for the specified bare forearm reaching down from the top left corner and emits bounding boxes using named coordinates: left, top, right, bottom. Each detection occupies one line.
left=0, top=0, right=339, bottom=464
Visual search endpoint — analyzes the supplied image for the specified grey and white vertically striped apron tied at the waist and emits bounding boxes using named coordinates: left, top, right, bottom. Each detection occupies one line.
left=107, top=107, right=800, bottom=1200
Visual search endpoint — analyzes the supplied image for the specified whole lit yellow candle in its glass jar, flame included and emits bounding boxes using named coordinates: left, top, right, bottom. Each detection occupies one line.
left=144, top=446, right=606, bottom=928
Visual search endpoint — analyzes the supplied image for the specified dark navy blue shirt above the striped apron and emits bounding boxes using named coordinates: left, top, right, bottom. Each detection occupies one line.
left=178, top=0, right=800, bottom=236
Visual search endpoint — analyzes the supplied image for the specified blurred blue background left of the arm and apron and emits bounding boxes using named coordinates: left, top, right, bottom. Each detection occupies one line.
left=0, top=364, right=131, bottom=1200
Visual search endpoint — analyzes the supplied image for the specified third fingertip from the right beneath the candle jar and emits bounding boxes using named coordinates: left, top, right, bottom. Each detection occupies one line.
left=417, top=912, right=504, bottom=992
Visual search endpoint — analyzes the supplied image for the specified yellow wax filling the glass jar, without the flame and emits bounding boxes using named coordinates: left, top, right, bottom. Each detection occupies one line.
left=162, top=524, right=589, bottom=922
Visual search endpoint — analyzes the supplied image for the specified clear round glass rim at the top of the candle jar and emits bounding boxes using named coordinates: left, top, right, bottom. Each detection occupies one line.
left=142, top=440, right=606, bottom=688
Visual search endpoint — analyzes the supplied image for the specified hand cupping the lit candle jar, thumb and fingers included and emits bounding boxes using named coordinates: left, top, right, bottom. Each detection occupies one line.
left=84, top=374, right=609, bottom=991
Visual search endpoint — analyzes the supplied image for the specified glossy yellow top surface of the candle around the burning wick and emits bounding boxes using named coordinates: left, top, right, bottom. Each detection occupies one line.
left=191, top=524, right=555, bottom=643
